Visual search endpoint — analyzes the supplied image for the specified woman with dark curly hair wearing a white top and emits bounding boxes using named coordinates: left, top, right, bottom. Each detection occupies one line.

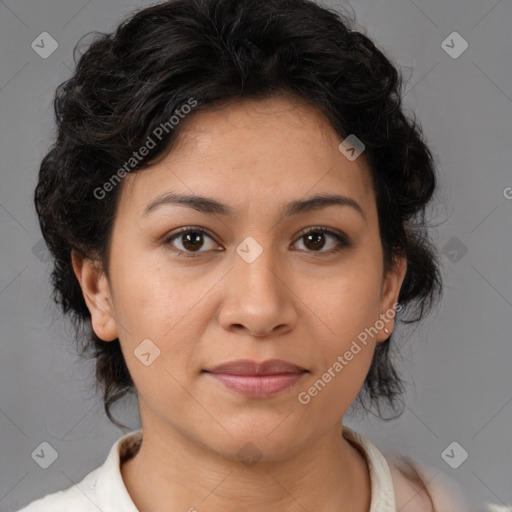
left=23, top=0, right=476, bottom=512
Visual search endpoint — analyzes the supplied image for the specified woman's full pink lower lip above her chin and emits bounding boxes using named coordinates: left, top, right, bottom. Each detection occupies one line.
left=208, top=372, right=306, bottom=398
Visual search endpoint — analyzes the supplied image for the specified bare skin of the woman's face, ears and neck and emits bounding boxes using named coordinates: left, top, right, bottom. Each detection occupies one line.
left=73, top=97, right=406, bottom=512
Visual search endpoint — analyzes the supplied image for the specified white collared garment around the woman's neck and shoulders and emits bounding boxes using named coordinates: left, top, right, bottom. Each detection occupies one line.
left=13, top=426, right=468, bottom=512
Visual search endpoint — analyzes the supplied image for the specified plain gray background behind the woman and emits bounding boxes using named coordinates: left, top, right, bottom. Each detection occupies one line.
left=0, top=0, right=512, bottom=511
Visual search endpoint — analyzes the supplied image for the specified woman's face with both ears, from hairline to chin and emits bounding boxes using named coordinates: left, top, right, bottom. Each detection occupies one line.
left=75, top=94, right=405, bottom=460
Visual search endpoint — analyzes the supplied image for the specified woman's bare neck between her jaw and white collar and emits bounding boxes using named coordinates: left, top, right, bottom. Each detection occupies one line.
left=121, top=424, right=371, bottom=512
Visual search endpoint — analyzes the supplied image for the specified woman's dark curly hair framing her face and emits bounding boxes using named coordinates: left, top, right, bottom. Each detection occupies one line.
left=35, top=0, right=442, bottom=440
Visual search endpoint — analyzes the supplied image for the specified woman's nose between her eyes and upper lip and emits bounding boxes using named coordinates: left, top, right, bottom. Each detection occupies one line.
left=219, top=242, right=298, bottom=338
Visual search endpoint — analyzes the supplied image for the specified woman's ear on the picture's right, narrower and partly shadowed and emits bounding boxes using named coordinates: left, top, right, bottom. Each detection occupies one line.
left=375, top=257, right=407, bottom=343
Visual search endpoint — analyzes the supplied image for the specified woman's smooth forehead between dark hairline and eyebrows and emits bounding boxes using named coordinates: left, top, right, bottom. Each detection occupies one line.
left=120, top=97, right=373, bottom=220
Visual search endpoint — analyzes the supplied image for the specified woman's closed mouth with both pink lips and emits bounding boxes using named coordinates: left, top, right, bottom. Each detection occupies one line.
left=203, top=359, right=309, bottom=398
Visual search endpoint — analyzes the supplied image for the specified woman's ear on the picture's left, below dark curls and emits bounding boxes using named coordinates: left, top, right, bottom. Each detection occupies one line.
left=71, top=250, right=118, bottom=341
